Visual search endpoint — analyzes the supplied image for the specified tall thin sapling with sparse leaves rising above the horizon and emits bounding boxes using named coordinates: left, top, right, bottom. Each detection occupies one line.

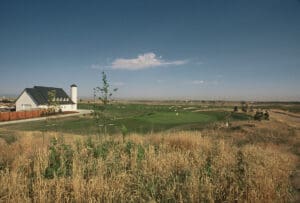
left=93, top=71, right=118, bottom=134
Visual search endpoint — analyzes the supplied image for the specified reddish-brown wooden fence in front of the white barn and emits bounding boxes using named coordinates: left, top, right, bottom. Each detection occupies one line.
left=0, top=110, right=44, bottom=121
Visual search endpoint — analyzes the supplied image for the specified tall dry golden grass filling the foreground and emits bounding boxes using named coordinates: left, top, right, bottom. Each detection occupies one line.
left=0, top=132, right=295, bottom=202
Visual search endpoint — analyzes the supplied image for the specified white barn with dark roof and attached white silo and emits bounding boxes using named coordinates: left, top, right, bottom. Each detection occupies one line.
left=16, top=84, right=77, bottom=111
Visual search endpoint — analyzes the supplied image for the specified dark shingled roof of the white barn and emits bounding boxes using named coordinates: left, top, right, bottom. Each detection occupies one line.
left=24, top=86, right=74, bottom=105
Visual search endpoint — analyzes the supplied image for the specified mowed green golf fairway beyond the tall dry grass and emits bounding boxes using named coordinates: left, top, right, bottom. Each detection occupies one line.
left=1, top=104, right=249, bottom=135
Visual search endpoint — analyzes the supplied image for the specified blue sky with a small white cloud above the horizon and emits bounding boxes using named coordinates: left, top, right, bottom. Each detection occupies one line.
left=0, top=0, right=300, bottom=101
